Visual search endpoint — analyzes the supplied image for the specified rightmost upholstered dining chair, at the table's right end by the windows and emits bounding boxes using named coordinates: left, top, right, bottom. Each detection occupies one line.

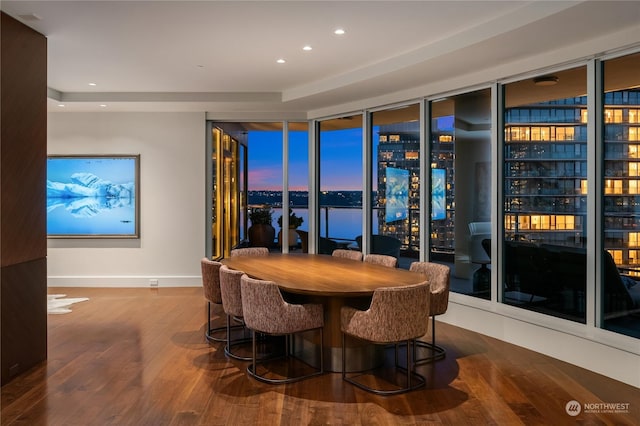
left=409, top=262, right=451, bottom=364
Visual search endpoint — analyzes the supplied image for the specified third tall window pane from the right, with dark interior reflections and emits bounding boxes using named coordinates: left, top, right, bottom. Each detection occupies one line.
left=429, top=88, right=492, bottom=299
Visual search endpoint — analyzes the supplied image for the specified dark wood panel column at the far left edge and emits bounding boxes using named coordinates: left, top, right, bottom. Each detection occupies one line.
left=0, top=13, right=47, bottom=385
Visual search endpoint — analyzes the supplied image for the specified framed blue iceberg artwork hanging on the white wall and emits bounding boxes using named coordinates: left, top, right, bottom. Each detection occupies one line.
left=47, top=155, right=140, bottom=238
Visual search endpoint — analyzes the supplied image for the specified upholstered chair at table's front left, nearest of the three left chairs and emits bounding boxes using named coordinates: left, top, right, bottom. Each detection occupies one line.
left=240, top=275, right=324, bottom=384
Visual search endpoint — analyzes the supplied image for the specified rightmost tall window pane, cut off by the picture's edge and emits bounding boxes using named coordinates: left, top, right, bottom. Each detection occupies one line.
left=601, top=53, right=640, bottom=337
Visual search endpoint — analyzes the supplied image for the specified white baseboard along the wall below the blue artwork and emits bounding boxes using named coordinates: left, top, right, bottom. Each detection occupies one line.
left=47, top=275, right=202, bottom=288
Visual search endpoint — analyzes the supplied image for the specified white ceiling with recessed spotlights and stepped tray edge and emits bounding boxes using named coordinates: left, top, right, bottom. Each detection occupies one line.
left=0, top=0, right=640, bottom=117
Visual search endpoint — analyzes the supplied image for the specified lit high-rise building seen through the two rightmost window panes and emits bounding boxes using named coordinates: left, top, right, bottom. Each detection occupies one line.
left=504, top=89, right=640, bottom=266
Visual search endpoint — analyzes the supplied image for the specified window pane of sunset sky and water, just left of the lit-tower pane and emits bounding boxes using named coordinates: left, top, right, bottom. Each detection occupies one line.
left=318, top=115, right=363, bottom=254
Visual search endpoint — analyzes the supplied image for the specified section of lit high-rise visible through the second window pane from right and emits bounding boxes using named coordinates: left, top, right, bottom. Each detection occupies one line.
left=504, top=96, right=587, bottom=247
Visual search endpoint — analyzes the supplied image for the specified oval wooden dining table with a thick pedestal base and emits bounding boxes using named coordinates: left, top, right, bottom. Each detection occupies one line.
left=221, top=253, right=428, bottom=371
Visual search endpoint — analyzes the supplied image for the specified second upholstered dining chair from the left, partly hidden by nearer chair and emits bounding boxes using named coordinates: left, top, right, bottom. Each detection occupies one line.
left=220, top=265, right=251, bottom=361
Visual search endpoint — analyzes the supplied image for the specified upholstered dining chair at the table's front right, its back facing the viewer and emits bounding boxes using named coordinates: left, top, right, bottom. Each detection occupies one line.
left=340, top=281, right=430, bottom=395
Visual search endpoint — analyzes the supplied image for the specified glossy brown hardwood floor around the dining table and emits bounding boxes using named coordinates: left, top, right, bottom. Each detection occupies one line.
left=1, top=288, right=640, bottom=426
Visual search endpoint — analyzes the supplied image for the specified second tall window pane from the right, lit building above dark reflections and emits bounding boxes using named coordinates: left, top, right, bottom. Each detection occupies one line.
left=502, top=67, right=588, bottom=322
